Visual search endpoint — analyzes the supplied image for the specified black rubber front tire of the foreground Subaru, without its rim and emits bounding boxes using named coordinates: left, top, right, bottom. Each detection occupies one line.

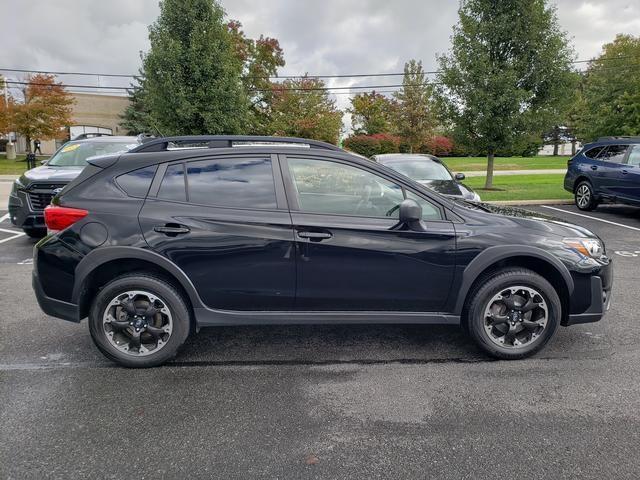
left=467, top=271, right=562, bottom=359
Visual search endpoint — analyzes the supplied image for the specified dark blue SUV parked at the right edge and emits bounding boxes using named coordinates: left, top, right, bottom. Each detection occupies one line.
left=564, top=137, right=640, bottom=210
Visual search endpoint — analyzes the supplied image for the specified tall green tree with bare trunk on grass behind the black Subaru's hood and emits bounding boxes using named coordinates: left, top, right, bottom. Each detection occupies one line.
left=436, top=0, right=573, bottom=188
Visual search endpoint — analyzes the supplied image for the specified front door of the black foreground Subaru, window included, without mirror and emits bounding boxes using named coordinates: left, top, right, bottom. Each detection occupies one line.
left=283, top=157, right=455, bottom=312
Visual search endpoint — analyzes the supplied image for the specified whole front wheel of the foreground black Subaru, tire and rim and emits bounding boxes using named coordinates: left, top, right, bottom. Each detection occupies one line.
left=463, top=268, right=562, bottom=360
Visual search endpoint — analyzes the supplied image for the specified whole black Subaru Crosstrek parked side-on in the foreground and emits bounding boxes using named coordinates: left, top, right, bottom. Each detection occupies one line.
left=33, top=136, right=612, bottom=367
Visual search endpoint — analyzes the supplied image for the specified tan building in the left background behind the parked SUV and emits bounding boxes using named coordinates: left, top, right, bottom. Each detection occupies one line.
left=17, top=93, right=129, bottom=155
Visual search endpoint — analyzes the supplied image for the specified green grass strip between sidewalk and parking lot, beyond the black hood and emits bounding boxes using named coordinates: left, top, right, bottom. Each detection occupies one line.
left=464, top=174, right=572, bottom=202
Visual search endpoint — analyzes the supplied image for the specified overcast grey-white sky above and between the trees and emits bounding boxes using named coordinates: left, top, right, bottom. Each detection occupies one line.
left=0, top=0, right=640, bottom=116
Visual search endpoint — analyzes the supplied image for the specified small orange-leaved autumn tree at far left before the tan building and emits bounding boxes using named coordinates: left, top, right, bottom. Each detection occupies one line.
left=13, top=74, right=74, bottom=152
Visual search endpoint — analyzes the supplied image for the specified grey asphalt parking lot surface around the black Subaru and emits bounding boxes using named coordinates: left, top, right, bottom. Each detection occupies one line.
left=0, top=205, right=640, bottom=479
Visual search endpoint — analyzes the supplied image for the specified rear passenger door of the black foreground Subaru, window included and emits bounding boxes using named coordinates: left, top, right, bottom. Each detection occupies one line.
left=140, top=154, right=295, bottom=311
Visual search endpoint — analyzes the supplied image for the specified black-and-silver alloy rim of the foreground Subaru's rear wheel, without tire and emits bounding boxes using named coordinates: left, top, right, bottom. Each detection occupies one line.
left=102, top=290, right=173, bottom=356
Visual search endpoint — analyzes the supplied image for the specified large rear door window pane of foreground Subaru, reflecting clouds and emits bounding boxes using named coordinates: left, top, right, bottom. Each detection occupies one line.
left=187, top=158, right=277, bottom=208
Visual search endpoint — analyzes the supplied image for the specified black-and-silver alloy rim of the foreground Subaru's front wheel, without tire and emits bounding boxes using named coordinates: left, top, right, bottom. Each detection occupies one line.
left=484, top=286, right=549, bottom=349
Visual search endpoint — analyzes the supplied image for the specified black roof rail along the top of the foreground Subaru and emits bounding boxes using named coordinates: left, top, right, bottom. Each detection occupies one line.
left=129, top=135, right=342, bottom=153
